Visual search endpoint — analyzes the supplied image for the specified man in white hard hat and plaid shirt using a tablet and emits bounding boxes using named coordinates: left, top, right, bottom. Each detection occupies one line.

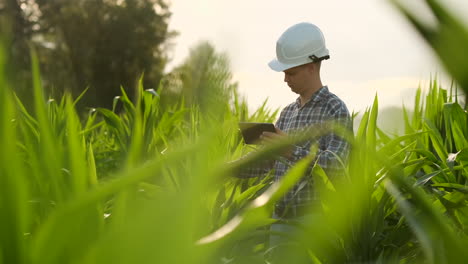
left=239, top=23, right=352, bottom=260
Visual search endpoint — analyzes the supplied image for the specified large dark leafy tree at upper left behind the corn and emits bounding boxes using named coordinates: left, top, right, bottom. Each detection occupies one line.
left=1, top=0, right=175, bottom=107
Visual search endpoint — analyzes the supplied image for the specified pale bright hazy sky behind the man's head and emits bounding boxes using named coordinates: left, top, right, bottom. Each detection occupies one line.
left=168, top=0, right=468, bottom=112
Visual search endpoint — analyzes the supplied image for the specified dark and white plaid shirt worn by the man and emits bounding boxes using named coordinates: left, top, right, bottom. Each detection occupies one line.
left=239, top=86, right=352, bottom=216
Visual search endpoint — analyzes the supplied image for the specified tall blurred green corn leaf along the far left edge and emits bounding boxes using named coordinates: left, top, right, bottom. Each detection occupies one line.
left=0, top=40, right=29, bottom=264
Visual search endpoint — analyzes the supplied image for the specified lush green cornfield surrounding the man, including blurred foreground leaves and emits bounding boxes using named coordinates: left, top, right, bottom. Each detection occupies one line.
left=0, top=1, right=468, bottom=264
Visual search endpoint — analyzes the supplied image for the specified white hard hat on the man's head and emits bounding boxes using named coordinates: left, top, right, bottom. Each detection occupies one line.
left=268, top=23, right=330, bottom=72
